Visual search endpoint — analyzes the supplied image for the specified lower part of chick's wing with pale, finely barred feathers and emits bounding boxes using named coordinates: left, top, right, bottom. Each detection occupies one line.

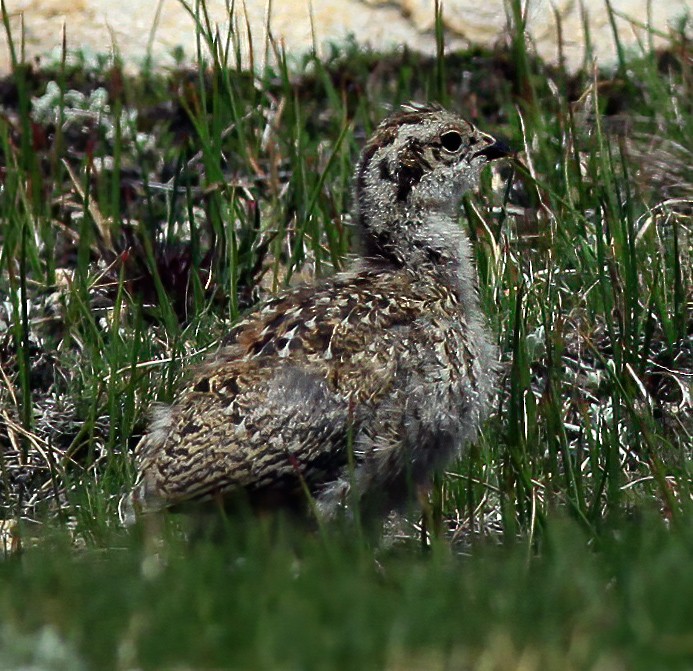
left=127, top=362, right=356, bottom=508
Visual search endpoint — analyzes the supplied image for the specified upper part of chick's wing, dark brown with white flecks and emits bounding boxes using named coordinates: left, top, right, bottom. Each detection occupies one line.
left=209, top=270, right=435, bottom=402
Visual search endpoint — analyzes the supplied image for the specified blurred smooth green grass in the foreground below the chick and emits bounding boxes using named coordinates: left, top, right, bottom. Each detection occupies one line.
left=0, top=518, right=693, bottom=671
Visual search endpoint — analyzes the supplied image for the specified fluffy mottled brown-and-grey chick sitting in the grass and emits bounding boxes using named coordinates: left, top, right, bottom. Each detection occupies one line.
left=120, top=103, right=510, bottom=524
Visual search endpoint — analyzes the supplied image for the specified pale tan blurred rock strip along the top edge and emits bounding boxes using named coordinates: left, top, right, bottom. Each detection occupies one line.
left=5, top=0, right=693, bottom=73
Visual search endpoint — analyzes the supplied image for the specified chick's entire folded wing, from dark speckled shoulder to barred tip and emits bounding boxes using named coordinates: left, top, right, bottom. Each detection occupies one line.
left=123, top=273, right=428, bottom=508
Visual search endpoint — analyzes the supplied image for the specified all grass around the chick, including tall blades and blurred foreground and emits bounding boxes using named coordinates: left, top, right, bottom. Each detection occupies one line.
left=0, top=4, right=693, bottom=670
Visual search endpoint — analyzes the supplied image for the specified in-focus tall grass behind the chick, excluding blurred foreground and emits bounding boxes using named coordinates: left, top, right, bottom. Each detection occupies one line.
left=0, top=3, right=691, bottom=535
